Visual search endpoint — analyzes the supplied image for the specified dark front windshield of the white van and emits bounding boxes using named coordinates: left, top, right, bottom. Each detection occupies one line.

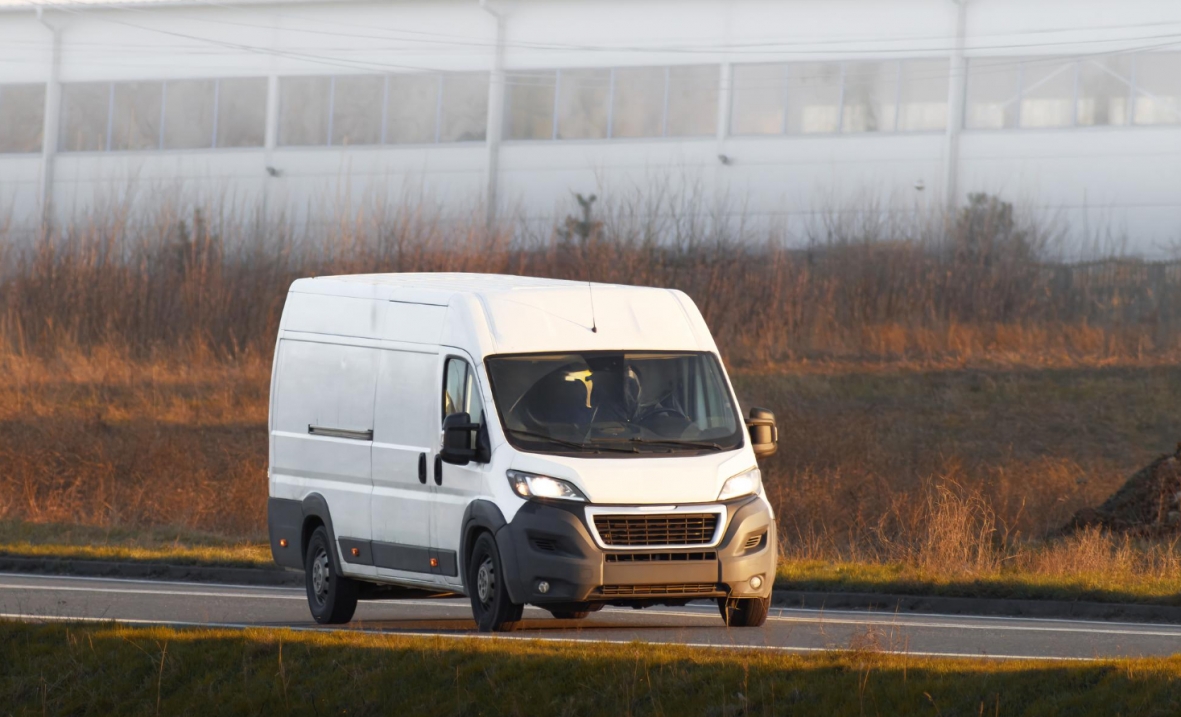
left=487, top=351, right=743, bottom=457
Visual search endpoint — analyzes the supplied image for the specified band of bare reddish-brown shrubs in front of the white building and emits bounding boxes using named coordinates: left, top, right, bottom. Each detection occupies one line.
left=0, top=191, right=1181, bottom=366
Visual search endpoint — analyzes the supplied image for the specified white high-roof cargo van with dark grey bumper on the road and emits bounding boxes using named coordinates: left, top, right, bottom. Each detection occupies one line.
left=267, top=274, right=777, bottom=631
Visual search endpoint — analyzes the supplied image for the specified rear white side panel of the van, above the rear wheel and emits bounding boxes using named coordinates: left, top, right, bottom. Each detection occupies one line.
left=270, top=338, right=381, bottom=575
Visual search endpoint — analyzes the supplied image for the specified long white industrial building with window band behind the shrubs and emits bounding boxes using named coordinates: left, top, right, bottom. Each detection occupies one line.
left=0, top=0, right=1181, bottom=255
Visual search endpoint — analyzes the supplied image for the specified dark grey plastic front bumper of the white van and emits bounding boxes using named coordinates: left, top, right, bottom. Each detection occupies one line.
left=496, top=496, right=777, bottom=605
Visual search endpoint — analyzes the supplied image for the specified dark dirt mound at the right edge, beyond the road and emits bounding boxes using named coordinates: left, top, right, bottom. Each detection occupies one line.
left=1062, top=443, right=1181, bottom=535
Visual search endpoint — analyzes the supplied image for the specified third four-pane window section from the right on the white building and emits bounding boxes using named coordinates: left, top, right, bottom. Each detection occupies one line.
left=504, top=65, right=719, bottom=139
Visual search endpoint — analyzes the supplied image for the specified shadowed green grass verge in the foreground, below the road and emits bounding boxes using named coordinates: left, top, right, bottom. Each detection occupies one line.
left=0, top=623, right=1181, bottom=716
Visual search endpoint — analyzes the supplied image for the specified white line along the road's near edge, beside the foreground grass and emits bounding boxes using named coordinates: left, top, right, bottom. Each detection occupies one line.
left=0, top=613, right=1095, bottom=663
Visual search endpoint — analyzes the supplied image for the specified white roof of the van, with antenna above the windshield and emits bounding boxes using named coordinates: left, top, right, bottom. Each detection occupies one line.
left=291, top=273, right=717, bottom=358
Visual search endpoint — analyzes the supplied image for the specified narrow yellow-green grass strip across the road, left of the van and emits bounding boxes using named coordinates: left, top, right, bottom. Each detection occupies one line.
left=0, top=521, right=274, bottom=568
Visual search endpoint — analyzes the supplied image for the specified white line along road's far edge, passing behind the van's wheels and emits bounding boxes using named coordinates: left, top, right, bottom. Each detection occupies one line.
left=0, top=584, right=1181, bottom=638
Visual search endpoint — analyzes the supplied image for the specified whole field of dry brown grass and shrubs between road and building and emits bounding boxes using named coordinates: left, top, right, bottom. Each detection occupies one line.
left=0, top=192, right=1181, bottom=588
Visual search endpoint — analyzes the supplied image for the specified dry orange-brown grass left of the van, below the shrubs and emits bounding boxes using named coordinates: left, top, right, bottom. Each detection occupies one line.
left=0, top=352, right=269, bottom=536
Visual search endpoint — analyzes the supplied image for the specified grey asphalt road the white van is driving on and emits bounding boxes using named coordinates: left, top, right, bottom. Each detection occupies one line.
left=0, top=574, right=1181, bottom=659
